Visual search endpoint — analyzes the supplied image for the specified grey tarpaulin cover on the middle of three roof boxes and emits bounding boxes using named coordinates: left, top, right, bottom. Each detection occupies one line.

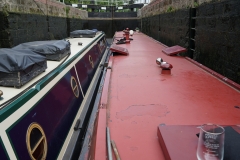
left=13, top=40, right=70, bottom=60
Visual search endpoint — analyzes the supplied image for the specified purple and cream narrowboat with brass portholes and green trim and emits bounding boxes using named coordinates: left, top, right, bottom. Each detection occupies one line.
left=0, top=30, right=108, bottom=160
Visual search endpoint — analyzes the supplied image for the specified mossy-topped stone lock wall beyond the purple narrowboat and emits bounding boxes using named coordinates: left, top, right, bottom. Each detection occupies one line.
left=0, top=0, right=87, bottom=48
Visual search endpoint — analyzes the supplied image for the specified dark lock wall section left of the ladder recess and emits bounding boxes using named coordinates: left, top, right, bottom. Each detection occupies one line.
left=142, top=10, right=189, bottom=48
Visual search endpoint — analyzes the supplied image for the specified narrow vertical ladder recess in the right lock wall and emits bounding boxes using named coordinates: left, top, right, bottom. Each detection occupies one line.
left=188, top=8, right=196, bottom=58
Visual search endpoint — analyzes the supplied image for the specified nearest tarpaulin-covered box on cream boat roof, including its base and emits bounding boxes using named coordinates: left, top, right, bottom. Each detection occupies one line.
left=0, top=48, right=47, bottom=88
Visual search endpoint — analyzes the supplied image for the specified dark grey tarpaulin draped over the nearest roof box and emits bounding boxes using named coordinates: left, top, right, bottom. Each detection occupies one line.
left=0, top=48, right=46, bottom=73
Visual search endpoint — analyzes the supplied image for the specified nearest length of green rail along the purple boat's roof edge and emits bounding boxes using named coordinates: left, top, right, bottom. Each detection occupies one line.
left=0, top=89, right=38, bottom=122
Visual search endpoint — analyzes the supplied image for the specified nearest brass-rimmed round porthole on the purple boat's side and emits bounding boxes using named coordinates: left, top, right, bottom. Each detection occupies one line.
left=26, top=122, right=47, bottom=160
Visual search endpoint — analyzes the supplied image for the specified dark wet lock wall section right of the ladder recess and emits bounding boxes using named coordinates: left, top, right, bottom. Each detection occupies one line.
left=194, top=0, right=240, bottom=84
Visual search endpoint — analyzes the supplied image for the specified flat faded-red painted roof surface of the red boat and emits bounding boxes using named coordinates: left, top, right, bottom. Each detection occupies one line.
left=95, top=32, right=240, bottom=160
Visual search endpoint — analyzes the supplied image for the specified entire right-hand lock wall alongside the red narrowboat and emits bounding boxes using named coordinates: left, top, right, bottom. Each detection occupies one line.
left=138, top=0, right=240, bottom=84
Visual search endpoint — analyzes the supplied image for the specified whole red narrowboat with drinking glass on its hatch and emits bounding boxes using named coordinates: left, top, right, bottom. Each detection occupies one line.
left=79, top=31, right=240, bottom=160
